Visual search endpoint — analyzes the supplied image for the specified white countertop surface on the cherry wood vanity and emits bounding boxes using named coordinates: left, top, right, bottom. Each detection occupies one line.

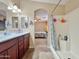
left=0, top=32, right=29, bottom=43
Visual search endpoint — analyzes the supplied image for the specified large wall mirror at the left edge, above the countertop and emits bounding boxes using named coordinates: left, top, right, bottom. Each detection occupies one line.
left=0, top=2, right=7, bottom=31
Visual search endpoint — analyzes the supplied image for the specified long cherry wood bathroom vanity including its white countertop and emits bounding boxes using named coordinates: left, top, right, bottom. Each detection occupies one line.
left=0, top=33, right=30, bottom=59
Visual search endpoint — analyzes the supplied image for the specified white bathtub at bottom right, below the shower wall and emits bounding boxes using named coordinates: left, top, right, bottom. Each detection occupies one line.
left=50, top=47, right=79, bottom=59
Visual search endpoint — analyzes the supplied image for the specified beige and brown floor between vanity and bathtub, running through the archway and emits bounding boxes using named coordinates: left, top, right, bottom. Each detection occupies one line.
left=23, top=39, right=54, bottom=59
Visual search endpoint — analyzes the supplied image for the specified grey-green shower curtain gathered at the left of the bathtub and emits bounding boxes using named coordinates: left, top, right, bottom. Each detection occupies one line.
left=49, top=16, right=58, bottom=50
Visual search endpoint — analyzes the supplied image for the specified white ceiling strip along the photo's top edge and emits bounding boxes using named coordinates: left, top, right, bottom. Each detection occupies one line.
left=32, top=0, right=68, bottom=5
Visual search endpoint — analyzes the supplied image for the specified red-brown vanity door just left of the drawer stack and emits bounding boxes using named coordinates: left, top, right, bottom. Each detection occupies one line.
left=8, top=44, right=18, bottom=59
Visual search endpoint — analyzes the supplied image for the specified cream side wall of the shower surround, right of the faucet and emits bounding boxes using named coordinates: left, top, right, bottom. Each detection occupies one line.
left=65, top=8, right=79, bottom=59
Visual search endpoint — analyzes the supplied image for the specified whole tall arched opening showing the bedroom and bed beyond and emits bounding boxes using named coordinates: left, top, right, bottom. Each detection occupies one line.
left=34, top=9, right=48, bottom=46
